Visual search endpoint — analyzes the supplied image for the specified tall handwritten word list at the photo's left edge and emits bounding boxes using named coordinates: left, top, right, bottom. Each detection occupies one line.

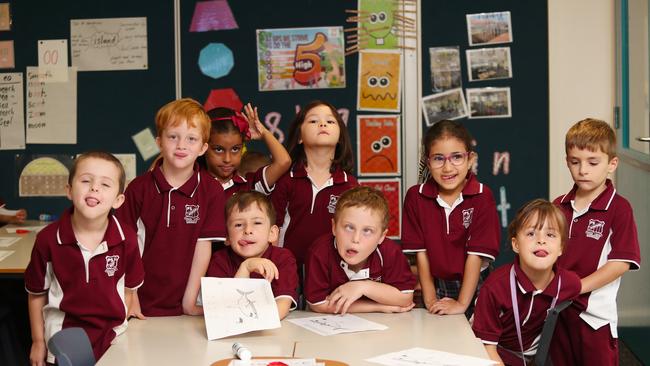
left=0, top=72, right=25, bottom=150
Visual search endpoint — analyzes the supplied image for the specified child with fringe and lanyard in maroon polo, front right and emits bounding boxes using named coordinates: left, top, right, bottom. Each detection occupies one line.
left=472, top=199, right=580, bottom=365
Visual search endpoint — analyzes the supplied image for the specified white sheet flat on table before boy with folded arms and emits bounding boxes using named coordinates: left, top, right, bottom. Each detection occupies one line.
left=288, top=314, right=388, bottom=336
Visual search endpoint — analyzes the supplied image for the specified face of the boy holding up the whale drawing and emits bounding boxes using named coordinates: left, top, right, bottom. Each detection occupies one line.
left=226, top=203, right=279, bottom=258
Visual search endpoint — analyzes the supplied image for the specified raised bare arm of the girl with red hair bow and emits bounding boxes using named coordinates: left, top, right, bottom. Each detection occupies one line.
left=244, top=103, right=291, bottom=187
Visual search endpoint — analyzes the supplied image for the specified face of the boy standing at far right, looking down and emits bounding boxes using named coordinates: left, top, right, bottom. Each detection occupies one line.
left=566, top=147, right=618, bottom=193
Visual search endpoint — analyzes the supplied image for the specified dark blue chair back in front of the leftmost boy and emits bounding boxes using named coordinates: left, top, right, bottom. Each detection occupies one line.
left=47, top=327, right=95, bottom=366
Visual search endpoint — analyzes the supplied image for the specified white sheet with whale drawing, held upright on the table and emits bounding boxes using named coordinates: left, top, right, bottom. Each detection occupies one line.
left=201, top=277, right=280, bottom=340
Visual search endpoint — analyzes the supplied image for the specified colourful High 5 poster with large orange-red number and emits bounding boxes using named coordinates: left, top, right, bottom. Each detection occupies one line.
left=257, top=27, right=345, bottom=91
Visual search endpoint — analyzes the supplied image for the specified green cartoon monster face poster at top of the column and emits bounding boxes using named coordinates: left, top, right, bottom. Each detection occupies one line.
left=359, top=0, right=397, bottom=49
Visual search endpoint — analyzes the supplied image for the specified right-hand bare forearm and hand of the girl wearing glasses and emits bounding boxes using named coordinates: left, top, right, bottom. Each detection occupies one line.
left=433, top=254, right=483, bottom=315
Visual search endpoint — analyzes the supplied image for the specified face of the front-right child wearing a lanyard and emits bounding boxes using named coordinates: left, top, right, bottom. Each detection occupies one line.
left=512, top=215, right=562, bottom=271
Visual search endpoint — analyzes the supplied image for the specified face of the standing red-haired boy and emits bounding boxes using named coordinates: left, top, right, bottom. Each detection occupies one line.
left=156, top=122, right=208, bottom=169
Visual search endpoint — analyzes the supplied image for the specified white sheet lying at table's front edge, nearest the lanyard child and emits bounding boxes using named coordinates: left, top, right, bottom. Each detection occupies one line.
left=366, top=347, right=496, bottom=366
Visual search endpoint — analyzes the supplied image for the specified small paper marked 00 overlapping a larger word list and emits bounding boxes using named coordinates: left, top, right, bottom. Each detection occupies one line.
left=38, top=39, right=68, bottom=83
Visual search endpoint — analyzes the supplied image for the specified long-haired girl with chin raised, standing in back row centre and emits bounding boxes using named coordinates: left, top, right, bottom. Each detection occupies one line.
left=271, top=100, right=358, bottom=266
